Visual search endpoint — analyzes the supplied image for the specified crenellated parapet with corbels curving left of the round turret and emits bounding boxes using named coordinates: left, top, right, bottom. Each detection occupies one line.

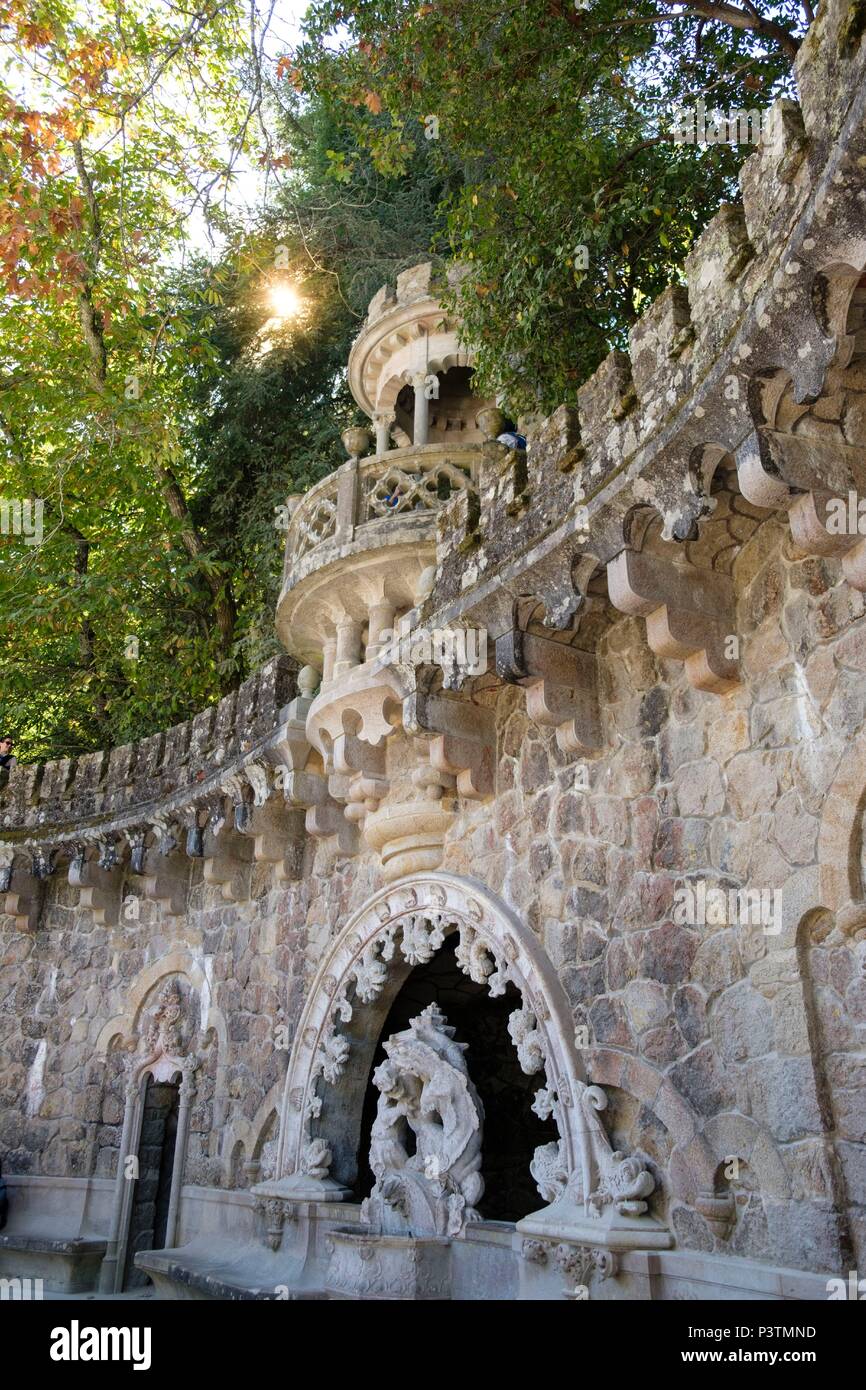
left=0, top=656, right=350, bottom=930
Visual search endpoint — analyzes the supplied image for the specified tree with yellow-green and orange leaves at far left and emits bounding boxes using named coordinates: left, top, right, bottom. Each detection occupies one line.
left=0, top=0, right=278, bottom=752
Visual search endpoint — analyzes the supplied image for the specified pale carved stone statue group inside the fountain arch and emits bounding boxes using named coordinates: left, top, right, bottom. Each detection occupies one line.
left=361, top=1004, right=484, bottom=1236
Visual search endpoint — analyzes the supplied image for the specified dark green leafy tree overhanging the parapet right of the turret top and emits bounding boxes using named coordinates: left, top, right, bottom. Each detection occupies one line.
left=292, top=0, right=812, bottom=410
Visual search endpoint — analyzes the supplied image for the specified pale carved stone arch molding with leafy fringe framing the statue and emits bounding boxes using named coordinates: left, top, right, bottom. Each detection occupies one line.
left=253, top=873, right=671, bottom=1248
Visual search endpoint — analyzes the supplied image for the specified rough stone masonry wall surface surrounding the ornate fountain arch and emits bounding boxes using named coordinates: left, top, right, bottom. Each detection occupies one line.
left=0, top=505, right=866, bottom=1270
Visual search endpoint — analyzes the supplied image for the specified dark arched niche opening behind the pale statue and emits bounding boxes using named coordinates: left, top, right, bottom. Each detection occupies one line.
left=357, top=933, right=559, bottom=1222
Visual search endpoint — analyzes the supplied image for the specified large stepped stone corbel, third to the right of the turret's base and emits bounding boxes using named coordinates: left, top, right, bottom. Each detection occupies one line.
left=607, top=550, right=740, bottom=695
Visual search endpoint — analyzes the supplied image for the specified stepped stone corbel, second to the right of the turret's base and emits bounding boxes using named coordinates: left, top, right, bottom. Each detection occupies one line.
left=496, top=628, right=602, bottom=758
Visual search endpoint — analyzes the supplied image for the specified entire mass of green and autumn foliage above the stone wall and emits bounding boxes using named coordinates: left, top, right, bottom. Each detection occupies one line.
left=0, top=0, right=803, bottom=759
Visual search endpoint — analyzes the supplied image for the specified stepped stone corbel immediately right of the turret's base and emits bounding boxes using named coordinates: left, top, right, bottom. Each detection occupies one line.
left=403, top=691, right=496, bottom=801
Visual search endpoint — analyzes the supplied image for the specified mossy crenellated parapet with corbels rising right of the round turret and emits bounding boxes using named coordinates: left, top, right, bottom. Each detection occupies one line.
left=433, top=3, right=866, bottom=706
